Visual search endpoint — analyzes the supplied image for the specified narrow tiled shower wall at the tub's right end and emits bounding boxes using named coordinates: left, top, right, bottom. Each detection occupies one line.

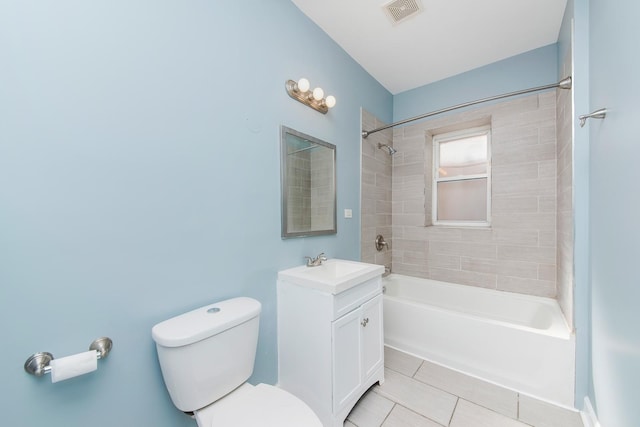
left=556, top=52, right=574, bottom=329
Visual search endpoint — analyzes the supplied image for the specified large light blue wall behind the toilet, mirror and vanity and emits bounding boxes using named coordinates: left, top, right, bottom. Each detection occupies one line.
left=0, top=0, right=392, bottom=427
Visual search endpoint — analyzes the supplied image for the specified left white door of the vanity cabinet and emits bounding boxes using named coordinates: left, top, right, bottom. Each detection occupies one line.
left=331, top=308, right=362, bottom=413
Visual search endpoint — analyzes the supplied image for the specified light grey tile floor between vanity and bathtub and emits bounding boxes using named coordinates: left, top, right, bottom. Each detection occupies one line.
left=344, top=347, right=583, bottom=427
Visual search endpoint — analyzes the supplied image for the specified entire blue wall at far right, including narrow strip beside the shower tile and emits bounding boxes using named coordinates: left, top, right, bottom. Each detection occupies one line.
left=559, top=0, right=640, bottom=427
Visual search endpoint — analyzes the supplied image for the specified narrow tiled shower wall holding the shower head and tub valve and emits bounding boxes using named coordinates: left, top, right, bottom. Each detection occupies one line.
left=360, top=110, right=393, bottom=267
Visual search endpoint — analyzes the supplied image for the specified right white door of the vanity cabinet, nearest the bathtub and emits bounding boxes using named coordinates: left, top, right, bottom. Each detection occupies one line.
left=360, top=295, right=384, bottom=380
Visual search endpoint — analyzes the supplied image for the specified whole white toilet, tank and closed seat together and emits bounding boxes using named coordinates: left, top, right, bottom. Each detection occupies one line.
left=151, top=297, right=322, bottom=427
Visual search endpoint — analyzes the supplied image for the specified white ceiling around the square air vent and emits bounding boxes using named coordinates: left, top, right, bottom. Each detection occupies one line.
left=292, top=0, right=567, bottom=94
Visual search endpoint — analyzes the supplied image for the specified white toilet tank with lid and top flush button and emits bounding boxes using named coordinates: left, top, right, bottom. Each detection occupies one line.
left=151, top=297, right=261, bottom=412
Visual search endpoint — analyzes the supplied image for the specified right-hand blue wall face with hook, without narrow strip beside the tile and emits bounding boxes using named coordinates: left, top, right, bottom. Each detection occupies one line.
left=588, top=0, right=640, bottom=427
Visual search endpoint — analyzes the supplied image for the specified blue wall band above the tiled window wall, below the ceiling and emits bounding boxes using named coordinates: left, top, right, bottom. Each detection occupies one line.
left=393, top=44, right=558, bottom=121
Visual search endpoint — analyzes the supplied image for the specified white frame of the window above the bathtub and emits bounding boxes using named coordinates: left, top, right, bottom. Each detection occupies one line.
left=431, top=125, right=491, bottom=227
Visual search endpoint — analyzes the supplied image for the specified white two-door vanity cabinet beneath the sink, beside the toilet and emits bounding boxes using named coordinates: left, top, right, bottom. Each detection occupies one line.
left=278, top=263, right=384, bottom=427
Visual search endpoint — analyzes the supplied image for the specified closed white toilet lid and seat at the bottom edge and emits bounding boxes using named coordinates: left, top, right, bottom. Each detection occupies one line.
left=195, top=383, right=322, bottom=427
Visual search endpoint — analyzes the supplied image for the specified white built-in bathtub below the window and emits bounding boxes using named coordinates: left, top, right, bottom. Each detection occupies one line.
left=382, top=274, right=575, bottom=407
